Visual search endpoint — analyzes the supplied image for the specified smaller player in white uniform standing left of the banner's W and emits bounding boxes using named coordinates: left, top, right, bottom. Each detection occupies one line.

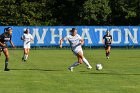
left=21, top=28, right=33, bottom=61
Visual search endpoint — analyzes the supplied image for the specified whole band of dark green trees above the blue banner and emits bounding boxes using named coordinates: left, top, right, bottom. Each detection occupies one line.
left=0, top=0, right=140, bottom=26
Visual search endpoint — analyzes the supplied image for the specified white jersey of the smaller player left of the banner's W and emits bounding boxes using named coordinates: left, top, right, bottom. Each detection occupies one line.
left=22, top=34, right=33, bottom=48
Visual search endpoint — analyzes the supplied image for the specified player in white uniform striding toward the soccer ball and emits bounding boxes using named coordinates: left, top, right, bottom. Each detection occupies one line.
left=60, top=28, right=92, bottom=71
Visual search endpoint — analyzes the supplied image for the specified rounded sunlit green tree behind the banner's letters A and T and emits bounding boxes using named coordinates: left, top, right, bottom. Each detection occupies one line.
left=80, top=0, right=111, bottom=25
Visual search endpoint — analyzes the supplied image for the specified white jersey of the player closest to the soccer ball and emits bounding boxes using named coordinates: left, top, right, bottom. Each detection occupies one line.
left=64, top=34, right=82, bottom=51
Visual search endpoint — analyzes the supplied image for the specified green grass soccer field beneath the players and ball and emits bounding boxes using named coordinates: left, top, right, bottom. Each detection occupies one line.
left=0, top=49, right=140, bottom=93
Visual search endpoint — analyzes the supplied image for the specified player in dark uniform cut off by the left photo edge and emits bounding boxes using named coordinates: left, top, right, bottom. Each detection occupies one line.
left=0, top=27, right=15, bottom=71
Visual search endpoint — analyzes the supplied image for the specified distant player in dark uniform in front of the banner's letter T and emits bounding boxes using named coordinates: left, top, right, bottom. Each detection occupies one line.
left=102, top=30, right=112, bottom=59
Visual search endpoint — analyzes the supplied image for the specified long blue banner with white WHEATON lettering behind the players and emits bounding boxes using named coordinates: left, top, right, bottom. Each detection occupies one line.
left=0, top=26, right=140, bottom=46
